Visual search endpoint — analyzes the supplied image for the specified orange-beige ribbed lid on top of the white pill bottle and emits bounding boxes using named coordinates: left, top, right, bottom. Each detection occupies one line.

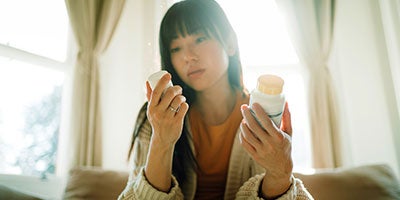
left=257, top=74, right=284, bottom=95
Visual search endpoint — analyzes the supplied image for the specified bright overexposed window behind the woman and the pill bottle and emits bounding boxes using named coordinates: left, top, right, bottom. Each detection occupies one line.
left=217, top=0, right=312, bottom=171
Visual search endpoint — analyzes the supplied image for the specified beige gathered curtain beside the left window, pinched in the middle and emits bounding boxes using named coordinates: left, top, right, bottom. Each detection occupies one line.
left=65, top=0, right=125, bottom=168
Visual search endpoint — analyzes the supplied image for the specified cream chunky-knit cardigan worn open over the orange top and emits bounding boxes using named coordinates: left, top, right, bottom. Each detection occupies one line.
left=118, top=110, right=313, bottom=200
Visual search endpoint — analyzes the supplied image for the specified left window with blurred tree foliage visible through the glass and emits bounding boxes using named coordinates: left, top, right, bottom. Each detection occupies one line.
left=0, top=0, right=69, bottom=176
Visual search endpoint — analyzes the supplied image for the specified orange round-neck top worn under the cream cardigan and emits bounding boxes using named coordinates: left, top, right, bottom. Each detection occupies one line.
left=189, top=93, right=249, bottom=199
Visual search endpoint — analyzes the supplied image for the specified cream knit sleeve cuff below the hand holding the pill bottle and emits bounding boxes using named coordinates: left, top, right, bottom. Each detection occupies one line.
left=236, top=173, right=314, bottom=200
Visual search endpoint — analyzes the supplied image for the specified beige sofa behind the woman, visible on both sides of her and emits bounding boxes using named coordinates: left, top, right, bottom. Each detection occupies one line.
left=0, top=164, right=400, bottom=200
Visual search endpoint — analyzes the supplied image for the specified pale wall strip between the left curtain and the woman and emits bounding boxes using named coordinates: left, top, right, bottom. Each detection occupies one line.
left=100, top=0, right=144, bottom=170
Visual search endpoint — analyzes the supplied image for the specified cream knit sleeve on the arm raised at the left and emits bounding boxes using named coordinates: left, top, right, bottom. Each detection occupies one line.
left=118, top=108, right=183, bottom=200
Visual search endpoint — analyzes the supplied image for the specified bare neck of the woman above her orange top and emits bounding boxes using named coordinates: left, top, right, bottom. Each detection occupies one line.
left=195, top=72, right=236, bottom=125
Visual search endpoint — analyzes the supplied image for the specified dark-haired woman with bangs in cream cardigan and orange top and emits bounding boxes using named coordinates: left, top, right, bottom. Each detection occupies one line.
left=119, top=0, right=312, bottom=199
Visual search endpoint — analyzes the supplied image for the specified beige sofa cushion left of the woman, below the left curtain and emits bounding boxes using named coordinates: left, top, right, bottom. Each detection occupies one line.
left=63, top=167, right=129, bottom=200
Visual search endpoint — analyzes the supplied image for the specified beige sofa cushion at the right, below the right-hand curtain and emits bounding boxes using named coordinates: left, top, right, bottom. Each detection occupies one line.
left=294, top=165, right=400, bottom=200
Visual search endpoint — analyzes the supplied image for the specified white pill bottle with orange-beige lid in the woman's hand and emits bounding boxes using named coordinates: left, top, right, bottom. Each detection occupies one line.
left=250, top=74, right=286, bottom=128
